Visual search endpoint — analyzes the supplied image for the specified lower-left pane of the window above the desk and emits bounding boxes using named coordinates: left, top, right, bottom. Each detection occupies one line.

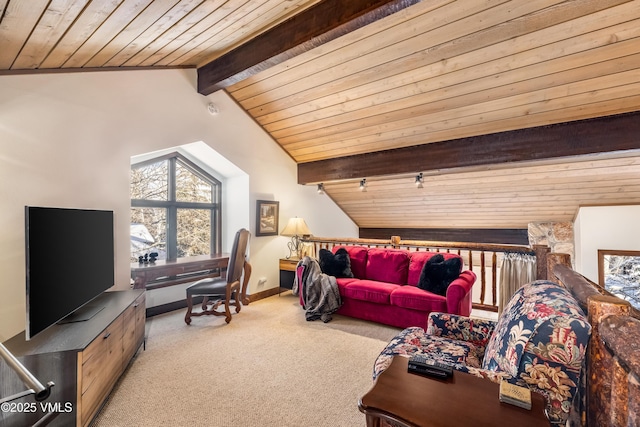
left=131, top=208, right=167, bottom=262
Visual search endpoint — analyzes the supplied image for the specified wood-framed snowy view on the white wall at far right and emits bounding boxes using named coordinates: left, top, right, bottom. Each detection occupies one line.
left=598, top=249, right=640, bottom=309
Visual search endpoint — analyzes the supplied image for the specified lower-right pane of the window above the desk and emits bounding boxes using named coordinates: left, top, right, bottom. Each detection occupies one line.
left=178, top=209, right=211, bottom=257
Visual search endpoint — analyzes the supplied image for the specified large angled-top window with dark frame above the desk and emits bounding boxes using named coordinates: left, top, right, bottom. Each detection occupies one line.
left=131, top=154, right=221, bottom=262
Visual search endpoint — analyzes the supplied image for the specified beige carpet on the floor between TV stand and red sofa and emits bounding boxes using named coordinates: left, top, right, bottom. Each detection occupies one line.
left=94, top=293, right=399, bottom=427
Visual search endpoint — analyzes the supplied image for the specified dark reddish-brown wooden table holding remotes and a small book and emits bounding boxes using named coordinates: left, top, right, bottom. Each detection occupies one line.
left=358, top=356, right=549, bottom=427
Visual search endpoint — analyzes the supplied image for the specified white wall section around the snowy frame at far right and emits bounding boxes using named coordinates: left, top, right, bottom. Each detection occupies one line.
left=574, top=205, right=640, bottom=283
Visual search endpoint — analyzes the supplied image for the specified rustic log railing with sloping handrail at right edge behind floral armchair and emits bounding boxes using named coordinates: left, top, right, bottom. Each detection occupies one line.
left=549, top=260, right=640, bottom=427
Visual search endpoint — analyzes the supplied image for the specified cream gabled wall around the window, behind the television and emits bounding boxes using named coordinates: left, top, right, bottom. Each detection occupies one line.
left=0, top=70, right=357, bottom=340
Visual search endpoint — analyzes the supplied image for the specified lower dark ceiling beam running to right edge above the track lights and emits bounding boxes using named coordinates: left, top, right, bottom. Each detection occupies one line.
left=298, top=112, right=640, bottom=184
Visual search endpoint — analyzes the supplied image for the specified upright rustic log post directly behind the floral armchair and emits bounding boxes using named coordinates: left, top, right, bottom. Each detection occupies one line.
left=586, top=295, right=631, bottom=426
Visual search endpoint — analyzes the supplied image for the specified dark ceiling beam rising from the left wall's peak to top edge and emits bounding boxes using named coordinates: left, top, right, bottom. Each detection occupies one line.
left=198, top=0, right=421, bottom=95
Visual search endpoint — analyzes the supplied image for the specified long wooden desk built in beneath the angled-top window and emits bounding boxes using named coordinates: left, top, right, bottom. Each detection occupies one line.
left=131, top=254, right=229, bottom=289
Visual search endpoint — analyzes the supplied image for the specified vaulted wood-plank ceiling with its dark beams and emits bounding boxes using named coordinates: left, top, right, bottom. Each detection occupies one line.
left=0, top=0, right=640, bottom=236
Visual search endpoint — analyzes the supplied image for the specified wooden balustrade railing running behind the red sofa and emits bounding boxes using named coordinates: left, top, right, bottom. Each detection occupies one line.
left=302, top=236, right=549, bottom=312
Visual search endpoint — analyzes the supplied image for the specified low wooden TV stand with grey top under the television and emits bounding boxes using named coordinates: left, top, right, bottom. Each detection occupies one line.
left=0, top=290, right=146, bottom=427
